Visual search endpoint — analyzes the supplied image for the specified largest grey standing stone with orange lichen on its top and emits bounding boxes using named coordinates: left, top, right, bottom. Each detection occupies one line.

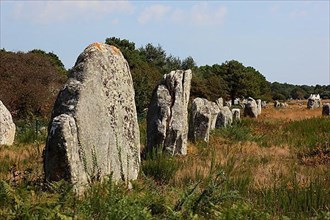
left=44, top=43, right=140, bottom=192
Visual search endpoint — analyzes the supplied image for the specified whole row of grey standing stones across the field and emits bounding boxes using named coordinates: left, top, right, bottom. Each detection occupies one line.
left=0, top=43, right=330, bottom=194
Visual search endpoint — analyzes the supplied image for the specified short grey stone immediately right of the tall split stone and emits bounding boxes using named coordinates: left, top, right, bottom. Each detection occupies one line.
left=189, top=98, right=212, bottom=142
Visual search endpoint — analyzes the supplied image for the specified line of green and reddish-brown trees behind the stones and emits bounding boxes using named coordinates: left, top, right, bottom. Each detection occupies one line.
left=0, top=37, right=330, bottom=118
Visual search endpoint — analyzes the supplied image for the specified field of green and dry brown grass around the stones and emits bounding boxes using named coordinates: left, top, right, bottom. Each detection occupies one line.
left=0, top=101, right=330, bottom=219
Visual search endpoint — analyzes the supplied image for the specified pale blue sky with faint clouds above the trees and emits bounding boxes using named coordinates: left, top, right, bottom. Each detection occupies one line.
left=0, top=0, right=330, bottom=85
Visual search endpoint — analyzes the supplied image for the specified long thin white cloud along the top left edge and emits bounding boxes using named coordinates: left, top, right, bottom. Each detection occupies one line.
left=13, top=0, right=134, bottom=24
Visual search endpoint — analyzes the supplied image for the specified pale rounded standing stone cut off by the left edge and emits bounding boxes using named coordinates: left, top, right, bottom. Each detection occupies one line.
left=0, top=101, right=16, bottom=145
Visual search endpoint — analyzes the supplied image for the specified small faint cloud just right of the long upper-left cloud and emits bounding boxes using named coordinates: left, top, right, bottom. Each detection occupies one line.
left=138, top=5, right=171, bottom=24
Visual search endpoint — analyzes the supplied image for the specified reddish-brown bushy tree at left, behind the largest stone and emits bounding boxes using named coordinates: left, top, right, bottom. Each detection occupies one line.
left=0, top=50, right=66, bottom=119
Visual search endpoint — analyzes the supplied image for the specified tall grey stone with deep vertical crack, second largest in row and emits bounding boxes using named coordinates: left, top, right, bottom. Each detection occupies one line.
left=147, top=70, right=192, bottom=155
